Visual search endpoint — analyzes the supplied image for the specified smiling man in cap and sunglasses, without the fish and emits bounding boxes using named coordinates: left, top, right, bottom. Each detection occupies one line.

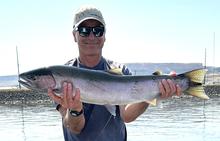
left=48, top=6, right=181, bottom=141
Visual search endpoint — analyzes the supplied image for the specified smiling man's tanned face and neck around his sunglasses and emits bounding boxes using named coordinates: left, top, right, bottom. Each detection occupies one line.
left=73, top=20, right=105, bottom=56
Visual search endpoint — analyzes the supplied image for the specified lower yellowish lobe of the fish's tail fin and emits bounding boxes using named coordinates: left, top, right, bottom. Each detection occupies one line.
left=185, top=86, right=209, bottom=100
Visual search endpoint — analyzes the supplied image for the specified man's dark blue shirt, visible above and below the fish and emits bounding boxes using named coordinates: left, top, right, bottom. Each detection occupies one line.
left=63, top=58, right=131, bottom=141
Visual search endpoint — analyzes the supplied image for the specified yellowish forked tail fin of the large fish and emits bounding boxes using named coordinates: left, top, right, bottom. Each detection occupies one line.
left=185, top=69, right=209, bottom=99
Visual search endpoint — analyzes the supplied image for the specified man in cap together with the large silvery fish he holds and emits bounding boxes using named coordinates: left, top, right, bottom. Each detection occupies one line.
left=19, top=6, right=209, bottom=141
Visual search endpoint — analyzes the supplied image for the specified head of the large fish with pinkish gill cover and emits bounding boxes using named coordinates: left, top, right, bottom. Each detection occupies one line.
left=19, top=68, right=56, bottom=91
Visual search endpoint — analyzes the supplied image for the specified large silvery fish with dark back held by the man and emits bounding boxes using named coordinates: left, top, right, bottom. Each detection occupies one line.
left=19, top=65, right=209, bottom=105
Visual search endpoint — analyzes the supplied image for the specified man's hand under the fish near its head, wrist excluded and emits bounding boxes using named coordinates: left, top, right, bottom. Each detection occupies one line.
left=48, top=82, right=82, bottom=111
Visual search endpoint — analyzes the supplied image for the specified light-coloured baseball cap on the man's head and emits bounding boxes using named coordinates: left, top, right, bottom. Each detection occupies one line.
left=73, top=5, right=105, bottom=29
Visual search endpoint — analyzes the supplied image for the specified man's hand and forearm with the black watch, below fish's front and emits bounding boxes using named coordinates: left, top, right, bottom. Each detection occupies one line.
left=48, top=82, right=85, bottom=134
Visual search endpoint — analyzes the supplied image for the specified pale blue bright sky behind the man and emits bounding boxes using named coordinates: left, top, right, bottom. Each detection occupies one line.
left=0, top=0, right=220, bottom=75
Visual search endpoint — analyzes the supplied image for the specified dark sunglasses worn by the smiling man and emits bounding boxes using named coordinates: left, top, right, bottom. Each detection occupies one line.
left=76, top=26, right=105, bottom=37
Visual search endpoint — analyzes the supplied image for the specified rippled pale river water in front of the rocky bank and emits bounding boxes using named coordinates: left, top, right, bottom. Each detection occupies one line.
left=0, top=96, right=220, bottom=141
